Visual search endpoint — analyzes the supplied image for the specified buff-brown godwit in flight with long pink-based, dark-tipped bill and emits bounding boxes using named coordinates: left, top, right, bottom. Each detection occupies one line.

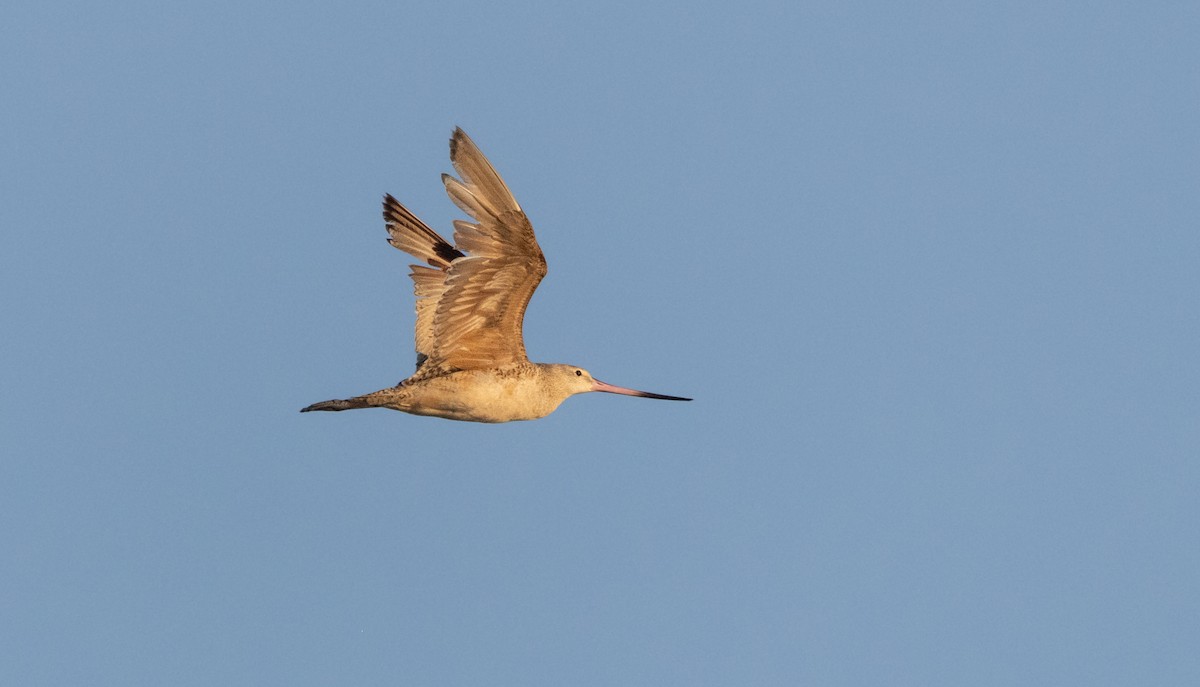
left=300, top=129, right=691, bottom=423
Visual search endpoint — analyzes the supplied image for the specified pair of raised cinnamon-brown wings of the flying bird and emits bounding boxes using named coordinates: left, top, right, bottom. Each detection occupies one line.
left=384, top=129, right=546, bottom=370
